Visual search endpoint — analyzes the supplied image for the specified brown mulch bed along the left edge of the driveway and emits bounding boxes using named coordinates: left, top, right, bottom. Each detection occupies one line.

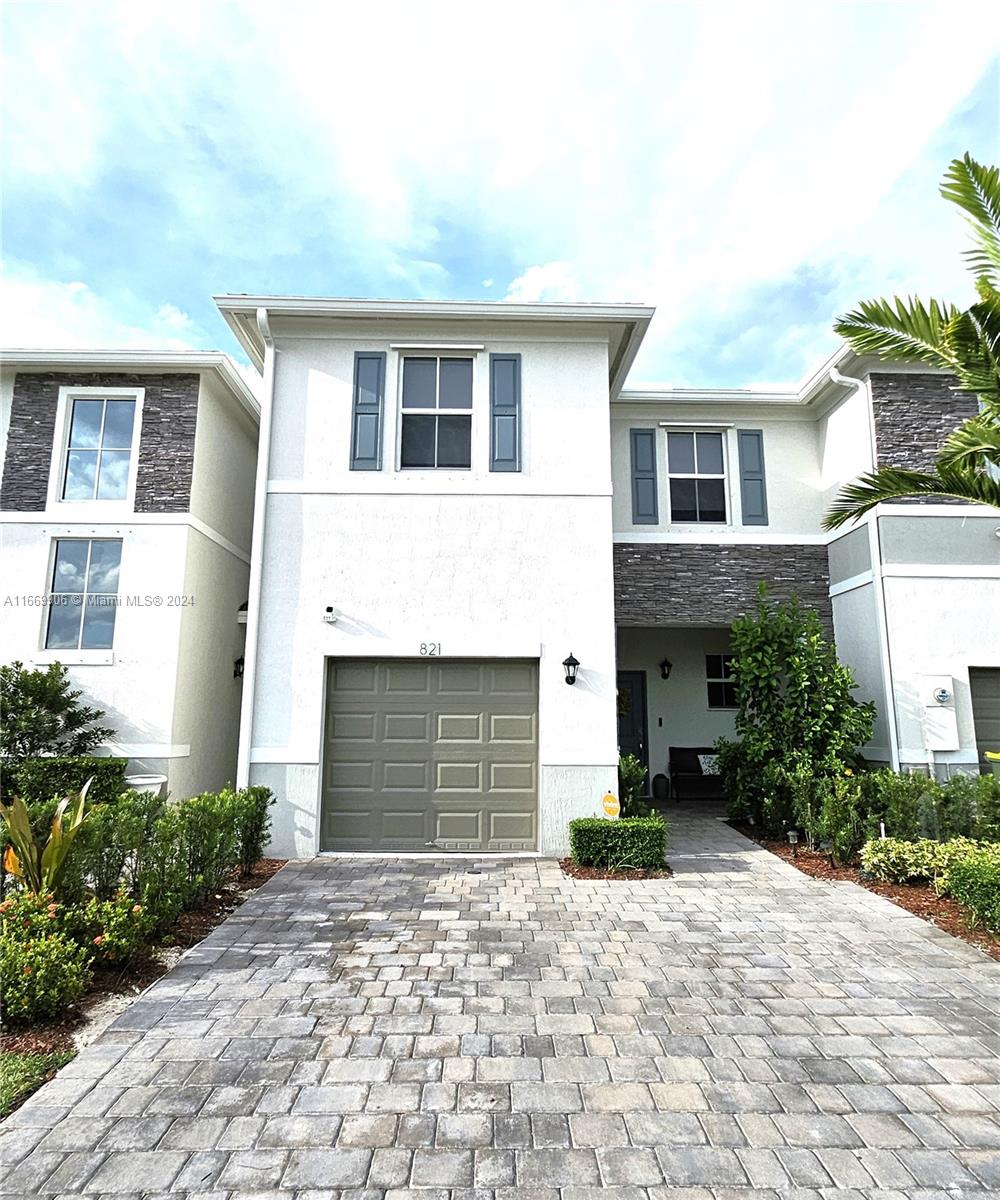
left=0, top=858, right=286, bottom=1054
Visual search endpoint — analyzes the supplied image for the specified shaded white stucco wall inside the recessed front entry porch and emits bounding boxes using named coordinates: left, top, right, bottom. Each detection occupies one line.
left=618, top=628, right=736, bottom=779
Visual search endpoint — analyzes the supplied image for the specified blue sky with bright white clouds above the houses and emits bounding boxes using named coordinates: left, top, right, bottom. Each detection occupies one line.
left=0, top=0, right=1000, bottom=388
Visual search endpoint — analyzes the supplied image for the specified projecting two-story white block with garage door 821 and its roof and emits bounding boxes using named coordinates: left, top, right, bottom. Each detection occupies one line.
left=217, top=296, right=652, bottom=854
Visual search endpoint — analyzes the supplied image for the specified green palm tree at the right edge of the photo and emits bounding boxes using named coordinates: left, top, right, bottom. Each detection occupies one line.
left=824, top=154, right=1000, bottom=529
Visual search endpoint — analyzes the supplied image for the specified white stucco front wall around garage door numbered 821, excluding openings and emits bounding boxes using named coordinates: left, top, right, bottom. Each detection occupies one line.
left=251, top=326, right=617, bottom=854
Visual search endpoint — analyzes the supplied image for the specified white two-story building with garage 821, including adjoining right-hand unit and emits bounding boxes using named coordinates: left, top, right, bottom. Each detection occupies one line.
left=217, top=296, right=1000, bottom=854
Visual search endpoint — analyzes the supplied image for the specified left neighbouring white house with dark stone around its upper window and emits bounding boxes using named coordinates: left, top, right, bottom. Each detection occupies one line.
left=0, top=350, right=259, bottom=797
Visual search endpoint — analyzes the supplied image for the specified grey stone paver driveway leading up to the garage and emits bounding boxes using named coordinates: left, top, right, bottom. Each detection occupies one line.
left=4, top=816, right=1000, bottom=1200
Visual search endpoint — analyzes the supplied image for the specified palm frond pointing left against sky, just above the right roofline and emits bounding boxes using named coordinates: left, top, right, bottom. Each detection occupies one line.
left=833, top=296, right=958, bottom=371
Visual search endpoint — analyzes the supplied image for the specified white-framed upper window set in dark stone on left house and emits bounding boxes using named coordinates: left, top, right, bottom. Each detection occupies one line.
left=58, top=389, right=142, bottom=502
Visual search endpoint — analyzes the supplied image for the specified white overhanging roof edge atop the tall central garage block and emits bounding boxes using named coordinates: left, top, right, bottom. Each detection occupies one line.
left=212, top=294, right=655, bottom=384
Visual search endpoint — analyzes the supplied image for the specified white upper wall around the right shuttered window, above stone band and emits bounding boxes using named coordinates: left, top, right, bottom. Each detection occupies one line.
left=611, top=403, right=821, bottom=541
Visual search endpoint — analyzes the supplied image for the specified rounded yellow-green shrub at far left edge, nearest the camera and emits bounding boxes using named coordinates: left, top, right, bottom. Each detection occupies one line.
left=0, top=893, right=90, bottom=1025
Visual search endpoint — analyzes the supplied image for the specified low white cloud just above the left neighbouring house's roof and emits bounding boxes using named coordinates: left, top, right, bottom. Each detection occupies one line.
left=0, top=265, right=202, bottom=350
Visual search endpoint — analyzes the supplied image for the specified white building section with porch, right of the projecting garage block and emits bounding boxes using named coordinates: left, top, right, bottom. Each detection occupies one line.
left=611, top=349, right=1000, bottom=775
